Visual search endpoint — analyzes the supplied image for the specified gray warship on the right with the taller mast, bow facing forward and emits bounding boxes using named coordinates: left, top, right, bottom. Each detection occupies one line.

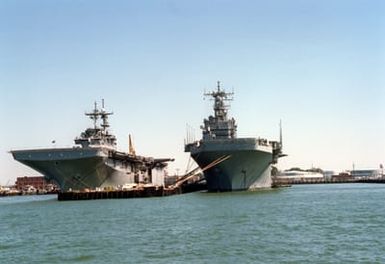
left=185, top=82, right=284, bottom=191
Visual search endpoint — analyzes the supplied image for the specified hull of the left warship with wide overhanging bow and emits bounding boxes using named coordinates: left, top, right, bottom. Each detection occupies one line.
left=12, top=148, right=135, bottom=190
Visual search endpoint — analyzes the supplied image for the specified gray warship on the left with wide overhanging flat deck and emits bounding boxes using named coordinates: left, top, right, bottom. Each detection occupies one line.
left=11, top=101, right=173, bottom=191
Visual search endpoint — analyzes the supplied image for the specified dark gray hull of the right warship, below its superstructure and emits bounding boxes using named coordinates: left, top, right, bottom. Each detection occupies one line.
left=188, top=138, right=272, bottom=192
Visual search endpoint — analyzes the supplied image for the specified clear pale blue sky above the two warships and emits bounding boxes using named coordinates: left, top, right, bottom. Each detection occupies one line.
left=0, top=0, right=385, bottom=184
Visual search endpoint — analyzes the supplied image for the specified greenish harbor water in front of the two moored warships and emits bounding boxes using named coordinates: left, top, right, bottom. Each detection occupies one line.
left=0, top=184, right=385, bottom=263
